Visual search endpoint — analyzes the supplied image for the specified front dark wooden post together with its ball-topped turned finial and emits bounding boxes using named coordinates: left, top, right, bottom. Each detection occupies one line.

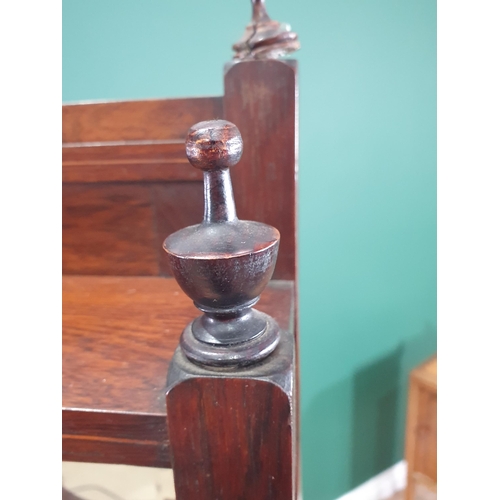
left=164, top=120, right=295, bottom=500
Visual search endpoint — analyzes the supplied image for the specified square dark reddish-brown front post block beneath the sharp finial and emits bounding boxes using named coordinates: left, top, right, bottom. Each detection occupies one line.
left=167, top=326, right=296, bottom=500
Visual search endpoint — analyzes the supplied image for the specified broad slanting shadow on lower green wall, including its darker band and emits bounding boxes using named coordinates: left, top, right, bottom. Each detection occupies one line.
left=301, top=325, right=436, bottom=500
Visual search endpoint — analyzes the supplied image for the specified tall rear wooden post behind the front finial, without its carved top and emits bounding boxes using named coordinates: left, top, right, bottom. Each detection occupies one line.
left=224, top=60, right=298, bottom=279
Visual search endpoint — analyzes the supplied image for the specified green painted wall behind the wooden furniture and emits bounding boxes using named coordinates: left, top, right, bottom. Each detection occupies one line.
left=63, top=0, right=436, bottom=500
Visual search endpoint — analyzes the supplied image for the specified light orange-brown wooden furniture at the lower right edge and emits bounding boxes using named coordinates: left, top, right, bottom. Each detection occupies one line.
left=405, top=357, right=437, bottom=500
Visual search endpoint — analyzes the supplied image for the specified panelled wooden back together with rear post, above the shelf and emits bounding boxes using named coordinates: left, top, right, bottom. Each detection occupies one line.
left=62, top=60, right=298, bottom=280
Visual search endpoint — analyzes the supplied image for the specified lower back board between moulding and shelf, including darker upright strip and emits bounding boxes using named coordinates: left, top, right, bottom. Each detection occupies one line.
left=62, top=181, right=203, bottom=276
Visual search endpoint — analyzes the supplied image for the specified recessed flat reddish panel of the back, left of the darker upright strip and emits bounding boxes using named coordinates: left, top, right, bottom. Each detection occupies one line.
left=62, top=184, right=159, bottom=275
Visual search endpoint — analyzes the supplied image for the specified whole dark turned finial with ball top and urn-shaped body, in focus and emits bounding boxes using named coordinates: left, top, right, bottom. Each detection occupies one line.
left=163, top=120, right=280, bottom=366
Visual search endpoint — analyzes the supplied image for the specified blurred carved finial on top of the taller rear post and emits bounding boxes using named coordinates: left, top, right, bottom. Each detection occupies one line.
left=233, top=0, right=300, bottom=60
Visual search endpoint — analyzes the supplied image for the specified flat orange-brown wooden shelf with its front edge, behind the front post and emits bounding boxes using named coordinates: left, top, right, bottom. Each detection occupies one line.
left=63, top=276, right=293, bottom=467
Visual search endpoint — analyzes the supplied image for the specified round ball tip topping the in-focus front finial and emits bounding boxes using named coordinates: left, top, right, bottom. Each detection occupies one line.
left=186, top=120, right=243, bottom=170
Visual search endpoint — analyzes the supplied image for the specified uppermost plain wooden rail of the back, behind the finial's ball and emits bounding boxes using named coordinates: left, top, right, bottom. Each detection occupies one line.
left=62, top=97, right=222, bottom=142
